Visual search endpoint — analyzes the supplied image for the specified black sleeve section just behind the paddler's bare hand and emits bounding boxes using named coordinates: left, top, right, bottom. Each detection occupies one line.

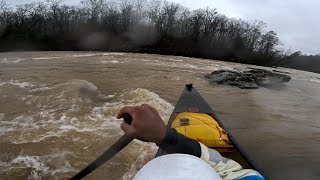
left=158, top=128, right=201, bottom=157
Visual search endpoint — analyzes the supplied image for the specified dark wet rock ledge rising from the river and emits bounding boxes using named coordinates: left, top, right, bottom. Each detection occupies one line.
left=205, top=68, right=291, bottom=89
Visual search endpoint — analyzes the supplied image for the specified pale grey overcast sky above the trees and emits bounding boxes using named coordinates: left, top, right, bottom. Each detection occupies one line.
left=7, top=0, right=320, bottom=54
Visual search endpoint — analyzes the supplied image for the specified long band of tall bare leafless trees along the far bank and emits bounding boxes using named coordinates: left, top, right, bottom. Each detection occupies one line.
left=0, top=0, right=290, bottom=66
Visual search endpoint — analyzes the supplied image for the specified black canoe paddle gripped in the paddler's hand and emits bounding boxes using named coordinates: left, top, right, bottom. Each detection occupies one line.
left=70, top=113, right=133, bottom=180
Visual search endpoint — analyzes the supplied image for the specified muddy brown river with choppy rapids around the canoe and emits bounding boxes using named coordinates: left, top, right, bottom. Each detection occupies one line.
left=0, top=52, right=320, bottom=179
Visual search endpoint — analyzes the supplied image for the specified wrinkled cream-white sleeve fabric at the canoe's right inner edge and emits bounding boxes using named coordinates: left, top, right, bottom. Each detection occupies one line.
left=200, top=143, right=264, bottom=180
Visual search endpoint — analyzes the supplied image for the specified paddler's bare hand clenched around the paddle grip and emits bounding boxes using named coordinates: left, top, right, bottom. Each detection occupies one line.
left=117, top=104, right=166, bottom=145
